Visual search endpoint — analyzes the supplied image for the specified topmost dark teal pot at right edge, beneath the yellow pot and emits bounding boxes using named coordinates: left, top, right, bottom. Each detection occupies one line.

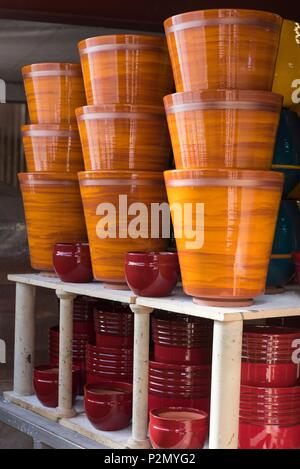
left=273, top=109, right=300, bottom=166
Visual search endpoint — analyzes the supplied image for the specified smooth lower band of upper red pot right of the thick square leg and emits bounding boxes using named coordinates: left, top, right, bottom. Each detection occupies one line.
left=241, top=362, right=298, bottom=388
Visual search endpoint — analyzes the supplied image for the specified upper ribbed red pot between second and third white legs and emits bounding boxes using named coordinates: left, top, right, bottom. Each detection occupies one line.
left=94, top=302, right=133, bottom=349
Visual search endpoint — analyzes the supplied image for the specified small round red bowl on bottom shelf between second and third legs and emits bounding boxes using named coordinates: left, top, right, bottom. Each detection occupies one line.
left=84, top=382, right=132, bottom=431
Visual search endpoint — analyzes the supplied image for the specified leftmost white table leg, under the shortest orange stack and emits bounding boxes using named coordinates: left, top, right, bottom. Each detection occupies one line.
left=14, top=283, right=36, bottom=396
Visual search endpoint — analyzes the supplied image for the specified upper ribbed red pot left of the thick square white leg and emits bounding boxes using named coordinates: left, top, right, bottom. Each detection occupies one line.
left=152, top=312, right=213, bottom=365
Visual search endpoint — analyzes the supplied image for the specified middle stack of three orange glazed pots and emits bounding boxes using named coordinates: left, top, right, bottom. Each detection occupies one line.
left=76, top=35, right=173, bottom=289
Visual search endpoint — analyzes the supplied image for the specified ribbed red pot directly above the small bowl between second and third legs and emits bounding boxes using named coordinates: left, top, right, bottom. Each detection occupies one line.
left=86, top=344, right=133, bottom=383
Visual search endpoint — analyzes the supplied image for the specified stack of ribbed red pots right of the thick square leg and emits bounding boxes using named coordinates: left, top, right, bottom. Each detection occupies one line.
left=239, top=325, right=300, bottom=449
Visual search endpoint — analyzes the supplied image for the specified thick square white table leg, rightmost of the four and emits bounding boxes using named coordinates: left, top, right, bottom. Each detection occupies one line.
left=209, top=321, right=243, bottom=449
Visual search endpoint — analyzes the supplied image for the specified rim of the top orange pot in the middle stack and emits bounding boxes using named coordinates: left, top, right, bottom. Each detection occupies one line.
left=78, top=34, right=167, bottom=55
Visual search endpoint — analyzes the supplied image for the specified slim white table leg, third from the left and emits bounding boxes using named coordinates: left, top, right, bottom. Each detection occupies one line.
left=128, top=305, right=153, bottom=449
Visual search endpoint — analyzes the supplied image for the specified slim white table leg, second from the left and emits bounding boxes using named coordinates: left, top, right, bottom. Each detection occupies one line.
left=56, top=290, right=76, bottom=418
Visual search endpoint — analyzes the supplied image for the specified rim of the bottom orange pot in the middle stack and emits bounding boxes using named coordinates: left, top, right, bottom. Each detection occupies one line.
left=78, top=170, right=164, bottom=185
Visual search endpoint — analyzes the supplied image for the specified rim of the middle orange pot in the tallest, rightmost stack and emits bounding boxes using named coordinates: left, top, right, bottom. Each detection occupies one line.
left=164, top=89, right=283, bottom=113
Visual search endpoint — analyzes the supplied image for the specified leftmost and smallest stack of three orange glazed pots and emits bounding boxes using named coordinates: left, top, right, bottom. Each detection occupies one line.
left=19, top=63, right=87, bottom=272
